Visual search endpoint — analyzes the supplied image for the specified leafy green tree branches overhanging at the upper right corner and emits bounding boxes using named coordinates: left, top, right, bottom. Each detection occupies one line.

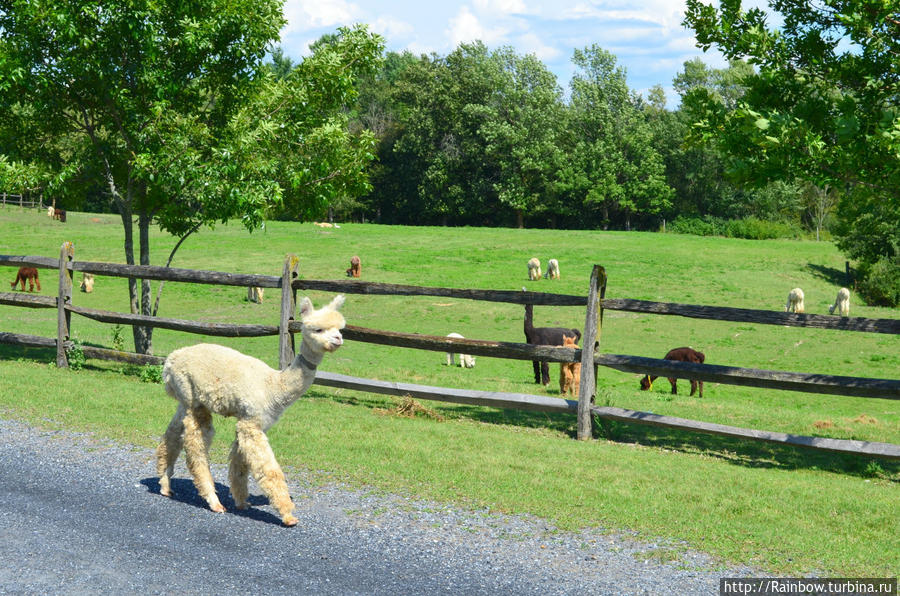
left=684, top=0, right=900, bottom=298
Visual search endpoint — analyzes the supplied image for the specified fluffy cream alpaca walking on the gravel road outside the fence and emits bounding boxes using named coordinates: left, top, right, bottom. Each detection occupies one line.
left=156, top=296, right=344, bottom=526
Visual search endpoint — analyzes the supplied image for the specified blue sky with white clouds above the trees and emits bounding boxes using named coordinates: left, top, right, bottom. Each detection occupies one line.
left=281, top=0, right=764, bottom=108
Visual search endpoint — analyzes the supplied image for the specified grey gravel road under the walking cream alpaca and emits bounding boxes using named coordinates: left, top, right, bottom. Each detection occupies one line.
left=0, top=419, right=753, bottom=596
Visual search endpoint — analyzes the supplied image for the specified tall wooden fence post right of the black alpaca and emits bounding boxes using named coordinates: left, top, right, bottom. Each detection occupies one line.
left=578, top=265, right=606, bottom=441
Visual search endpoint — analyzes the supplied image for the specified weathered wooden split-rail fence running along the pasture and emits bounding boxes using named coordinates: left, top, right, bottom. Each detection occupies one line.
left=0, top=242, right=900, bottom=460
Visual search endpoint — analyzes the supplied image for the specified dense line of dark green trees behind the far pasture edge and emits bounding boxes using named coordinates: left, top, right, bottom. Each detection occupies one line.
left=322, top=43, right=808, bottom=233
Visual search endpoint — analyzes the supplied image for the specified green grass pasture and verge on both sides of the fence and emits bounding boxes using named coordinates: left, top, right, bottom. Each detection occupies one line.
left=0, top=207, right=900, bottom=576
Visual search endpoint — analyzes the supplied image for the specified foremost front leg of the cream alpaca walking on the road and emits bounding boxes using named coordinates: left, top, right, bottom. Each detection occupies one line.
left=236, top=420, right=299, bottom=526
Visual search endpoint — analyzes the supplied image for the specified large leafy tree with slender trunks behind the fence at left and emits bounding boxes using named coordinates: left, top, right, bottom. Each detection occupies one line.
left=0, top=0, right=381, bottom=353
